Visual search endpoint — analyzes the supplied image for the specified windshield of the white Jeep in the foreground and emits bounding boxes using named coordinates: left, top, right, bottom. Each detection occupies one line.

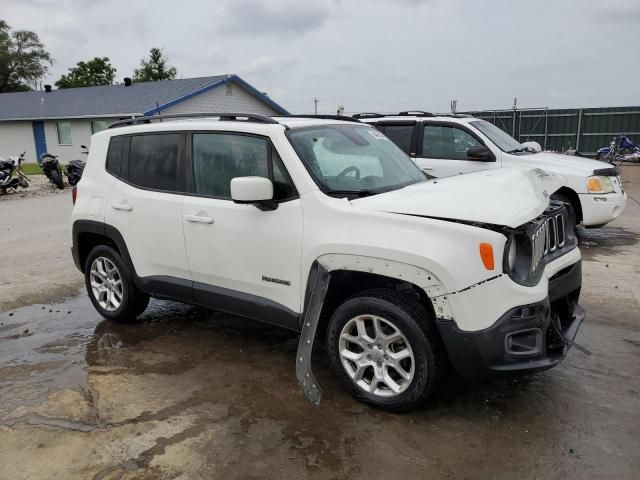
left=288, top=125, right=426, bottom=196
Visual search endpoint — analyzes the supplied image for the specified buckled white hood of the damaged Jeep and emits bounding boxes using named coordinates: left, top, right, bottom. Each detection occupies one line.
left=351, top=167, right=566, bottom=227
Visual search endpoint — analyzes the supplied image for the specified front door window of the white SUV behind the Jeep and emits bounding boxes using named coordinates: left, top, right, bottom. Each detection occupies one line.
left=422, top=125, right=481, bottom=160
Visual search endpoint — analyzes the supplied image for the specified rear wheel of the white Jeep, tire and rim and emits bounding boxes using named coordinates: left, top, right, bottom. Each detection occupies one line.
left=84, top=245, right=149, bottom=323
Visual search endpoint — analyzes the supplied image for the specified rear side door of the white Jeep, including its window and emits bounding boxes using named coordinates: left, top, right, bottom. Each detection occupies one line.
left=105, top=132, right=191, bottom=284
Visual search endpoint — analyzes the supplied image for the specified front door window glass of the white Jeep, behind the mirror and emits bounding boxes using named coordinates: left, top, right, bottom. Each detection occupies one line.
left=192, top=133, right=297, bottom=200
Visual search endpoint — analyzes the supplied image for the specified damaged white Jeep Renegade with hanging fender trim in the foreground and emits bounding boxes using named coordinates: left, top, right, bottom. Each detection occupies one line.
left=72, top=113, right=584, bottom=411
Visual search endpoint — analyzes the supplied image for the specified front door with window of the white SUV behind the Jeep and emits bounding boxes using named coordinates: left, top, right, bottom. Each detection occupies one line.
left=416, top=122, right=500, bottom=177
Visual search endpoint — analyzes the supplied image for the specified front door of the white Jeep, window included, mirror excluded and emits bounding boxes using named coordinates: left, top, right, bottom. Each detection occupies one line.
left=182, top=132, right=302, bottom=328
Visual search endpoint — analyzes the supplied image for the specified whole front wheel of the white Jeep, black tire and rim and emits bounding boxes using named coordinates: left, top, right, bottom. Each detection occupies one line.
left=327, top=289, right=446, bottom=412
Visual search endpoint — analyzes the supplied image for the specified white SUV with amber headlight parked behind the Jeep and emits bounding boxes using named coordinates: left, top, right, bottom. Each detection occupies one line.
left=354, top=111, right=627, bottom=227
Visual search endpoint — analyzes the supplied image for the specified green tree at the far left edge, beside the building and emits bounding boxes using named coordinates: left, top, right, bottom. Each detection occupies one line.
left=0, top=20, right=53, bottom=93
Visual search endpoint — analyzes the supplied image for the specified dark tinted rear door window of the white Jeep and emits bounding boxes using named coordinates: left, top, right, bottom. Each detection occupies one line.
left=129, top=133, right=182, bottom=192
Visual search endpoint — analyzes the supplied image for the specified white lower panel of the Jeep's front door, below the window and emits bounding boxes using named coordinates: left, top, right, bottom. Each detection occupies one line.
left=183, top=197, right=302, bottom=312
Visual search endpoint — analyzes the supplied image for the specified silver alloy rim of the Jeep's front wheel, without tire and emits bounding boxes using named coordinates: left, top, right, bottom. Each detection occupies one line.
left=338, top=315, right=415, bottom=397
